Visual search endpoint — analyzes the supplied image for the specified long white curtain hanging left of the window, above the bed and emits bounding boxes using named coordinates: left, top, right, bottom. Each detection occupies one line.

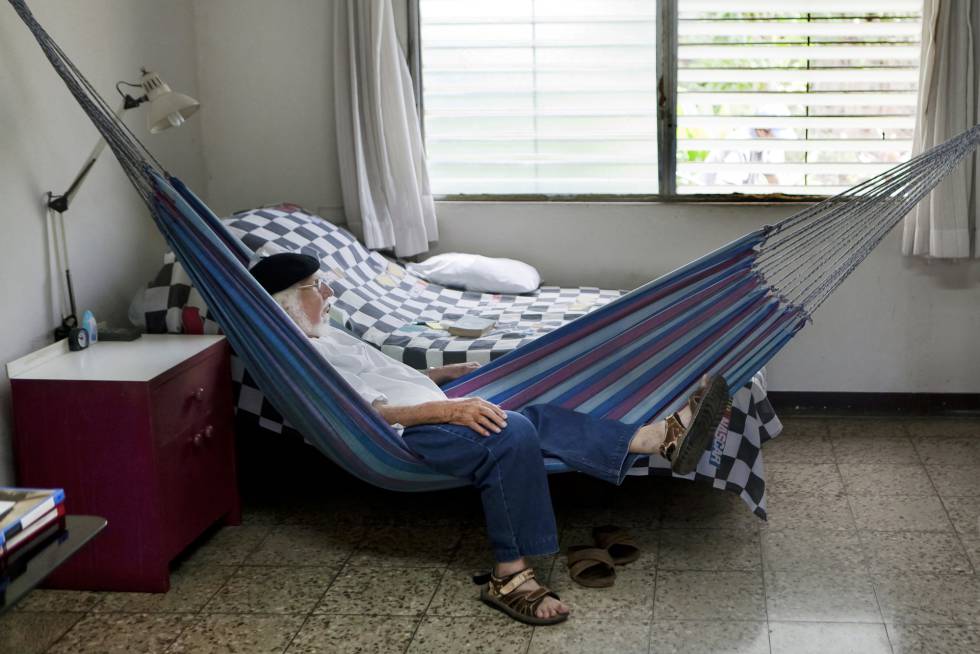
left=334, top=0, right=438, bottom=257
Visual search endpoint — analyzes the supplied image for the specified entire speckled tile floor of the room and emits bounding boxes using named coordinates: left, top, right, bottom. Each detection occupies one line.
left=0, top=419, right=980, bottom=654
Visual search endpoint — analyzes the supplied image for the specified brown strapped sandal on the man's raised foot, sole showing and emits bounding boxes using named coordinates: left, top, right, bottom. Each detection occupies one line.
left=660, top=375, right=728, bottom=475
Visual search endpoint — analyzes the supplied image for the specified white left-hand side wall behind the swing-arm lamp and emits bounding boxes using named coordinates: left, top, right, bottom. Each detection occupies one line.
left=0, top=0, right=203, bottom=485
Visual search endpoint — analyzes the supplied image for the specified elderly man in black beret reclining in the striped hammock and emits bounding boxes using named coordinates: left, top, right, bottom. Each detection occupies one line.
left=252, top=253, right=728, bottom=625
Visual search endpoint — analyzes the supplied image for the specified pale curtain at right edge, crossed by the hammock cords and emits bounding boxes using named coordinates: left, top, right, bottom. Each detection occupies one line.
left=902, top=0, right=980, bottom=259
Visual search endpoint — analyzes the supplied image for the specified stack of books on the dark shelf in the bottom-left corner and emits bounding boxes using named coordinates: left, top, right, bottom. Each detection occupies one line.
left=0, top=487, right=65, bottom=571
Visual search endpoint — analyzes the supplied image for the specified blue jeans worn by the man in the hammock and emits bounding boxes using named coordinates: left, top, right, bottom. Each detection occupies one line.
left=403, top=404, right=637, bottom=562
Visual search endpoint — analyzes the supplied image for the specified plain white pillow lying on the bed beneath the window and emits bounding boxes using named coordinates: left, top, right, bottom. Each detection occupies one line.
left=408, top=252, right=541, bottom=293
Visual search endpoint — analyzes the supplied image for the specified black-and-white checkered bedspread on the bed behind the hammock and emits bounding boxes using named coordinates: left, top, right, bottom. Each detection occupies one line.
left=143, top=205, right=781, bottom=517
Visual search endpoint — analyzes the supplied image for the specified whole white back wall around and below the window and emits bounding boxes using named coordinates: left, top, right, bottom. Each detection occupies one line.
left=197, top=0, right=980, bottom=400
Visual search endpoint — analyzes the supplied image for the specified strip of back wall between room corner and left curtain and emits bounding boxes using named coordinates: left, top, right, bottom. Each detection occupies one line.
left=194, top=0, right=342, bottom=220
